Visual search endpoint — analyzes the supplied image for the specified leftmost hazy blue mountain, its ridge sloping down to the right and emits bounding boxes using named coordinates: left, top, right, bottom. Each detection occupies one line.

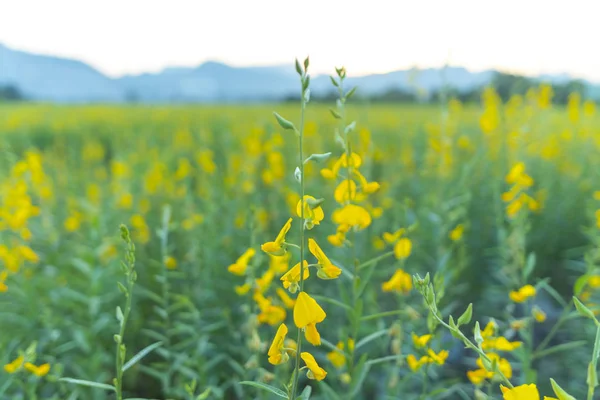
left=0, top=44, right=124, bottom=103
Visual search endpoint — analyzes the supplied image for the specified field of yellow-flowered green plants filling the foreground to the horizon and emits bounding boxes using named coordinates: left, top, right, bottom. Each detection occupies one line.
left=0, top=65, right=600, bottom=400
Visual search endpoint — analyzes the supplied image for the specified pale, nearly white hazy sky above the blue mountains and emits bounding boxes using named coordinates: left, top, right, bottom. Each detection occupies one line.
left=0, top=0, right=600, bottom=81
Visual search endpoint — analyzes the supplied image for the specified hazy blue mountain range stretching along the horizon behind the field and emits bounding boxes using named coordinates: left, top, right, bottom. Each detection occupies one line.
left=0, top=44, right=600, bottom=103
